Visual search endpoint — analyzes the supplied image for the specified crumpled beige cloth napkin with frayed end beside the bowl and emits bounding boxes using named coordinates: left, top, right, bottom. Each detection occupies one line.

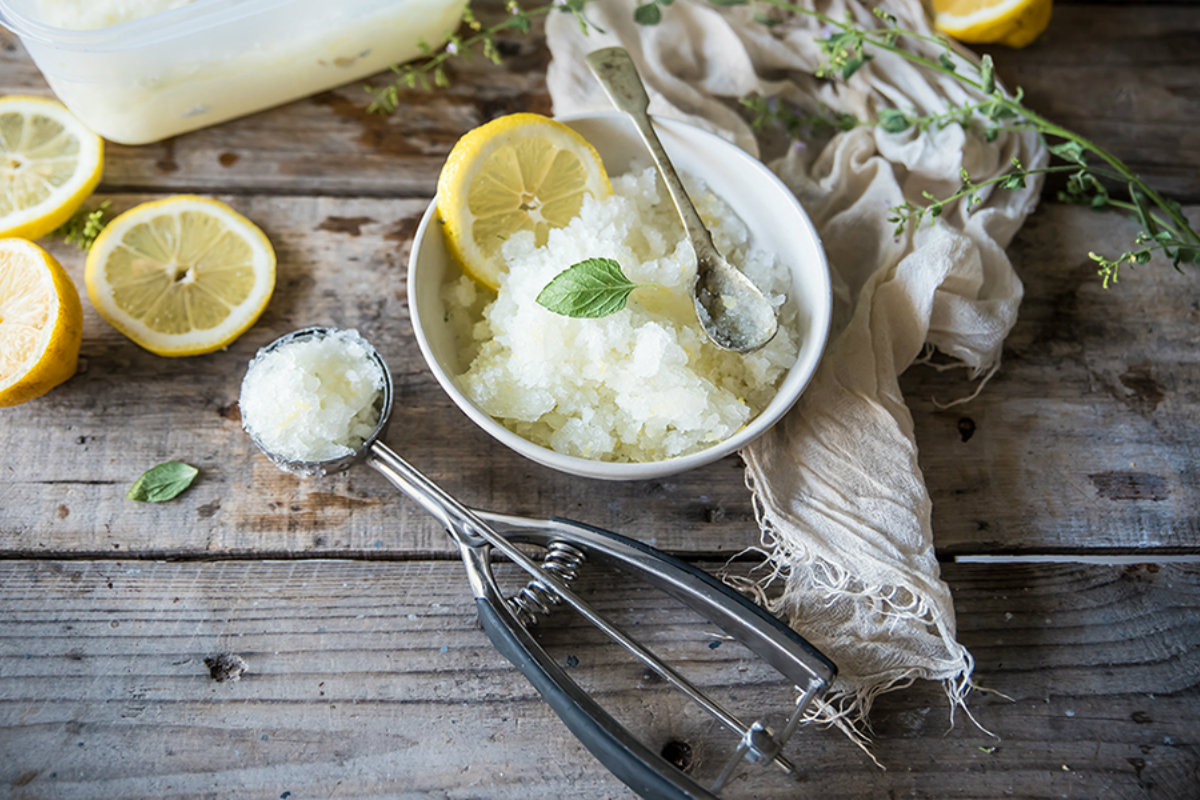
left=546, top=0, right=1046, bottom=744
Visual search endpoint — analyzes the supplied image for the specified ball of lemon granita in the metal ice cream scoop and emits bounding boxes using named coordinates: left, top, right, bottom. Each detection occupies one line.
left=239, top=330, right=385, bottom=463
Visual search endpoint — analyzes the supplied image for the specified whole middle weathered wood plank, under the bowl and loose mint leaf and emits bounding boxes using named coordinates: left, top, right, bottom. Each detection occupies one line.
left=0, top=196, right=1200, bottom=555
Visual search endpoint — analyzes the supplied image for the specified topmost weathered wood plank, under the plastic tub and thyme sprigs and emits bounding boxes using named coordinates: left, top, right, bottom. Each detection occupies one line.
left=0, top=7, right=1200, bottom=201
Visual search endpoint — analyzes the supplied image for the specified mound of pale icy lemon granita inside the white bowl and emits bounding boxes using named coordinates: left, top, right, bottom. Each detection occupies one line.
left=443, top=169, right=798, bottom=462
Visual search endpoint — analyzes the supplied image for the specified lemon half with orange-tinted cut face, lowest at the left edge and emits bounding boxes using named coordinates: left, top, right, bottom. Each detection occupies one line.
left=0, top=239, right=83, bottom=408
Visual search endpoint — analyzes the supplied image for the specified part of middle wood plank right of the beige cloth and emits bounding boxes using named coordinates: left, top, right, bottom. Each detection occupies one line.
left=902, top=204, right=1200, bottom=553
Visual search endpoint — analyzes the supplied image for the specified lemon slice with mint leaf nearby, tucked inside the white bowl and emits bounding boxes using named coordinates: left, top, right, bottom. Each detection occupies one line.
left=438, top=114, right=612, bottom=289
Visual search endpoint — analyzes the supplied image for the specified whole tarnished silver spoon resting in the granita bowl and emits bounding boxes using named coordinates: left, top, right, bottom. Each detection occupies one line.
left=587, top=47, right=779, bottom=353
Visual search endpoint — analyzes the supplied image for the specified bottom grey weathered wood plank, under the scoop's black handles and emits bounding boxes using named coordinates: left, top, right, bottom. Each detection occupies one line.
left=0, top=560, right=1200, bottom=800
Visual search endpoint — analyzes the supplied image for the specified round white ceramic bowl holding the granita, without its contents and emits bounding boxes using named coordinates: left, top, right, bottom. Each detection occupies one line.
left=408, top=113, right=832, bottom=481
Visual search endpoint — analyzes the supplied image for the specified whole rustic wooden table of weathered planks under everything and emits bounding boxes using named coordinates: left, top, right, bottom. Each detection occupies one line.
left=0, top=0, right=1200, bottom=800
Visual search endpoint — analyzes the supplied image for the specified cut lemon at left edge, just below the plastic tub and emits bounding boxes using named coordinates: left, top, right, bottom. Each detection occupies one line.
left=0, top=95, right=104, bottom=239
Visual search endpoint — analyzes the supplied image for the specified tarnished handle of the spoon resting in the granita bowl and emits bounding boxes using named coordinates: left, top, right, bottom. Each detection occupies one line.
left=587, top=47, right=715, bottom=257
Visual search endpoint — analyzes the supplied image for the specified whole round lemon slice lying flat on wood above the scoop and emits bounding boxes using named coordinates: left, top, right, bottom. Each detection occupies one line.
left=84, top=194, right=275, bottom=355
